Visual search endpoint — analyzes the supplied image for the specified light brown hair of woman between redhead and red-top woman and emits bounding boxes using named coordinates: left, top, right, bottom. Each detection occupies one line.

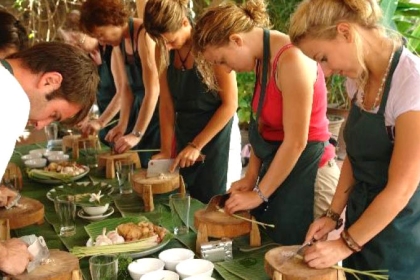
left=143, top=0, right=191, bottom=73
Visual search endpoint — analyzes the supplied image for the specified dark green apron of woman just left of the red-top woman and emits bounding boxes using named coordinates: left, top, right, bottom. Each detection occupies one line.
left=167, top=51, right=233, bottom=203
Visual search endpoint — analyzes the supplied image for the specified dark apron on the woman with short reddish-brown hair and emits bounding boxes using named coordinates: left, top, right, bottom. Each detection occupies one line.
left=121, top=18, right=160, bottom=168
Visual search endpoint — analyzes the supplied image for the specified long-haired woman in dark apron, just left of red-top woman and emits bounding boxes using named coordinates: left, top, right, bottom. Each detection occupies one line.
left=144, top=0, right=241, bottom=203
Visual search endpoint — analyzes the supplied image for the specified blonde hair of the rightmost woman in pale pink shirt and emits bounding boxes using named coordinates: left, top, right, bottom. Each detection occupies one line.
left=289, top=0, right=401, bottom=88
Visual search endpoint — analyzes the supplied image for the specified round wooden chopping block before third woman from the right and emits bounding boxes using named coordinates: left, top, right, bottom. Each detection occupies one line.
left=132, top=169, right=179, bottom=196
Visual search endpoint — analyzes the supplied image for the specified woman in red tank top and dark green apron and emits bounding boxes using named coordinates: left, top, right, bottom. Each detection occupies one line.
left=194, top=1, right=339, bottom=245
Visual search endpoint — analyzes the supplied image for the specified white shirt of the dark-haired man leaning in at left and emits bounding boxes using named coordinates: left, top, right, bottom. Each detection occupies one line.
left=0, top=64, right=30, bottom=179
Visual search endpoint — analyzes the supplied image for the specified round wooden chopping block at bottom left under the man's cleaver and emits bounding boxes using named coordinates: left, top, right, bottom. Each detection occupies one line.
left=11, top=250, right=79, bottom=280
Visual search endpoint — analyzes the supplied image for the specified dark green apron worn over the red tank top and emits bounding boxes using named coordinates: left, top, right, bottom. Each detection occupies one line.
left=249, top=30, right=326, bottom=245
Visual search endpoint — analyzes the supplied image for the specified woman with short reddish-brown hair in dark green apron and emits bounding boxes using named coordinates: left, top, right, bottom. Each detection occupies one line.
left=81, top=0, right=160, bottom=167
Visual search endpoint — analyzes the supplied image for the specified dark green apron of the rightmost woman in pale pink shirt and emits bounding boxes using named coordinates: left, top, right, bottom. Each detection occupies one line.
left=343, top=48, right=420, bottom=280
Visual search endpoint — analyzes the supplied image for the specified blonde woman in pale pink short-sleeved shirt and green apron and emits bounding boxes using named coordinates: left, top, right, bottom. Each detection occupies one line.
left=290, top=0, right=420, bottom=280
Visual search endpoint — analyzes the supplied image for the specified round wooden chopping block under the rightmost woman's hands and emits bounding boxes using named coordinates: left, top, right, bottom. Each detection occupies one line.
left=264, top=246, right=345, bottom=280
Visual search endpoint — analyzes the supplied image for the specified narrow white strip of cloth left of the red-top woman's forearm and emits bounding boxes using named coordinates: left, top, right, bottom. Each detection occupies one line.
left=226, top=113, right=242, bottom=190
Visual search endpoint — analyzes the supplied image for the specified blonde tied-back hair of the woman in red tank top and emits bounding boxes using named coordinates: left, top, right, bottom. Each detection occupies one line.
left=193, top=0, right=271, bottom=89
